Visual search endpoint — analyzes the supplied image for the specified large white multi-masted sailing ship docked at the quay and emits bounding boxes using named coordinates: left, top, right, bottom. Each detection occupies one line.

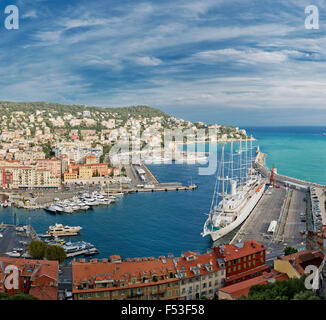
left=202, top=140, right=266, bottom=241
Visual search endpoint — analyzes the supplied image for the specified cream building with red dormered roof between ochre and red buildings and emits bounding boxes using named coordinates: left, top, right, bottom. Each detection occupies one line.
left=174, top=250, right=225, bottom=300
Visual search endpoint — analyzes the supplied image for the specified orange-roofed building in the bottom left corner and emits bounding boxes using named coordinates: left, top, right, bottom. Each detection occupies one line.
left=0, top=257, right=59, bottom=300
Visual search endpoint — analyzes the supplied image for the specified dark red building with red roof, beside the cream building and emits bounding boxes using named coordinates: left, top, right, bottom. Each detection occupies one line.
left=214, top=240, right=269, bottom=286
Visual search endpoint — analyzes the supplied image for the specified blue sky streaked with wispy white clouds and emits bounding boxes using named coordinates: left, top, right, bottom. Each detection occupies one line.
left=0, top=0, right=326, bottom=126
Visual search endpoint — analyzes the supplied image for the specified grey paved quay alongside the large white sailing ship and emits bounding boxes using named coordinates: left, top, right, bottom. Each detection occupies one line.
left=231, top=149, right=320, bottom=261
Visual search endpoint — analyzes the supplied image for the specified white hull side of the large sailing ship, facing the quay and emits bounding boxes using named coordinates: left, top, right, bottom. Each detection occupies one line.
left=210, top=183, right=266, bottom=241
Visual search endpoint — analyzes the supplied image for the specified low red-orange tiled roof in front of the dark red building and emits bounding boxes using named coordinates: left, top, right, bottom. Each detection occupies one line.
left=220, top=270, right=289, bottom=299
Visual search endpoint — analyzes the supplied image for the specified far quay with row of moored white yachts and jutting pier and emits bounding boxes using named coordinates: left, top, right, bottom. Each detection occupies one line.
left=5, top=164, right=198, bottom=214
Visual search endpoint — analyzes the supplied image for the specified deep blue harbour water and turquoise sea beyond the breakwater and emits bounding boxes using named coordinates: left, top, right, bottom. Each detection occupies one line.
left=0, top=127, right=326, bottom=258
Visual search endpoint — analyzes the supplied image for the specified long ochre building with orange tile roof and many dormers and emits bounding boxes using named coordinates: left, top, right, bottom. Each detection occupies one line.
left=72, top=255, right=180, bottom=300
